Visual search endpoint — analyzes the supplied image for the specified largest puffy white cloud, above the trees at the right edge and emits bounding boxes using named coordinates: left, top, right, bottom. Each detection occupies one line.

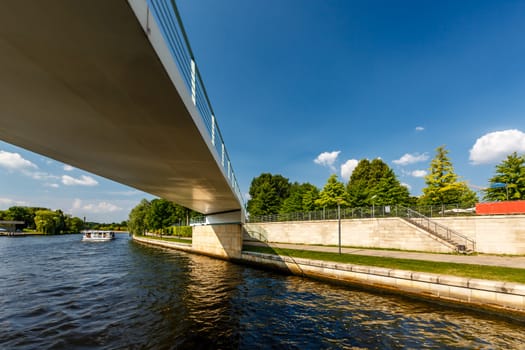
left=470, top=129, right=525, bottom=164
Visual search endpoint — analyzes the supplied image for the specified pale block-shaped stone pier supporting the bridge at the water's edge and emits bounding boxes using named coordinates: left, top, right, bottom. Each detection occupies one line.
left=192, top=224, right=243, bottom=260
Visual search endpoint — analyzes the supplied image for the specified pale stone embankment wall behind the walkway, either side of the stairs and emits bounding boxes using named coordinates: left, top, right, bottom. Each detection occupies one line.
left=244, top=215, right=525, bottom=254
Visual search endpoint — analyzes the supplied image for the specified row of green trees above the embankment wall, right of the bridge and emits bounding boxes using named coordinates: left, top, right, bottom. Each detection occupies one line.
left=248, top=146, right=525, bottom=216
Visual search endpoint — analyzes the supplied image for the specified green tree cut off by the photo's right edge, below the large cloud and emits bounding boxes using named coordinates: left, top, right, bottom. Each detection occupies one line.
left=484, top=152, right=525, bottom=201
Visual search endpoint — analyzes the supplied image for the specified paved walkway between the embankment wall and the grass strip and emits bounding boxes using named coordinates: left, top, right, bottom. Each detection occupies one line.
left=244, top=241, right=525, bottom=269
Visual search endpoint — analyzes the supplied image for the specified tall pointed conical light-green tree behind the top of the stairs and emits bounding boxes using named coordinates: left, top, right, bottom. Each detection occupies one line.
left=420, top=146, right=477, bottom=206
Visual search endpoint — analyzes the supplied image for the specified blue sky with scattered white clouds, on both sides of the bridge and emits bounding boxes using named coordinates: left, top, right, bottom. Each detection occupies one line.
left=0, top=0, right=525, bottom=221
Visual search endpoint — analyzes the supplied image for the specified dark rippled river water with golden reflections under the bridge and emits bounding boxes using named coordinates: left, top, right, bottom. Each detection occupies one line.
left=0, top=234, right=525, bottom=349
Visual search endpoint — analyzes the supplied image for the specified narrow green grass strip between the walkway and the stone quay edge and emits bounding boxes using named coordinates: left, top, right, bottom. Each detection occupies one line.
left=243, top=246, right=525, bottom=284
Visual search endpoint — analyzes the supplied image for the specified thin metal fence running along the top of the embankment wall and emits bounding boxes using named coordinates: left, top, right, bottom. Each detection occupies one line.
left=248, top=204, right=475, bottom=222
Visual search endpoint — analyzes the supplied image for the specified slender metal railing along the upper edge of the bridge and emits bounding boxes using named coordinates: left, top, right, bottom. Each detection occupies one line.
left=147, top=0, right=245, bottom=207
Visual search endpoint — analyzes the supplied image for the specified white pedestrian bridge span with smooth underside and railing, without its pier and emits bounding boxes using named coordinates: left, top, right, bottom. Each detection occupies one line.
left=0, top=0, right=244, bottom=223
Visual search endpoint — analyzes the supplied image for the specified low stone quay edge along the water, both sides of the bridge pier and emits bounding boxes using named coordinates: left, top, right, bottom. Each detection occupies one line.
left=133, top=236, right=525, bottom=319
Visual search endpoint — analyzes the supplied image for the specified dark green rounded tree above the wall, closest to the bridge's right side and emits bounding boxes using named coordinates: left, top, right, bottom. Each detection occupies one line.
left=248, top=173, right=291, bottom=215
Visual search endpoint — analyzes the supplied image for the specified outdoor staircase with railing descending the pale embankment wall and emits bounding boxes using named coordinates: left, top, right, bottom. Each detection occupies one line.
left=403, top=208, right=476, bottom=254
